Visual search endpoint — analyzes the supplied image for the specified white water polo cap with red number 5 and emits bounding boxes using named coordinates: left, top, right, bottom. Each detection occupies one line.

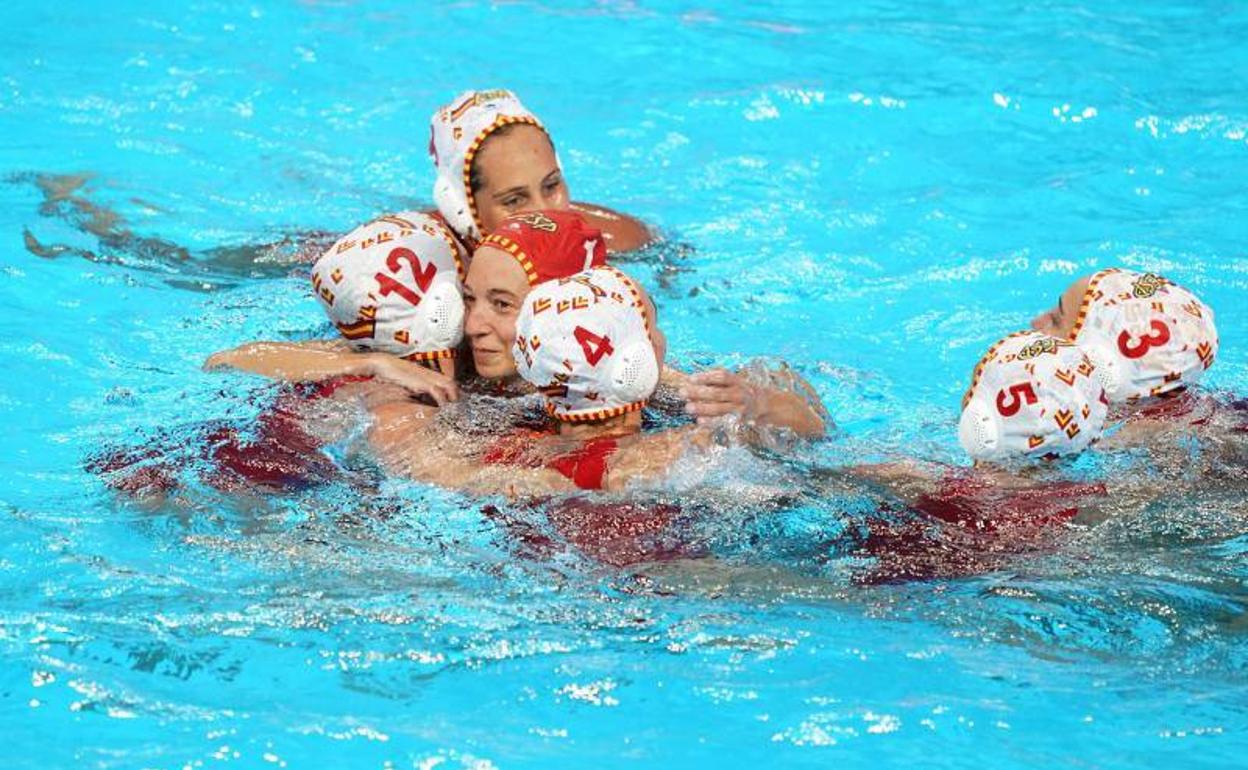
left=957, top=332, right=1109, bottom=461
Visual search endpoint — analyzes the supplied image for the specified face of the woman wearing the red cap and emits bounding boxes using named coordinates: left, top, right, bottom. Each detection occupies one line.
left=464, top=246, right=529, bottom=379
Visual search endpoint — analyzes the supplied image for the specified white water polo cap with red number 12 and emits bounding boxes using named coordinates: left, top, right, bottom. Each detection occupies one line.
left=312, top=211, right=464, bottom=361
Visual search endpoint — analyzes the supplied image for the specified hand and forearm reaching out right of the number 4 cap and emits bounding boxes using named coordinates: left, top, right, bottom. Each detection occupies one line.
left=680, top=369, right=826, bottom=438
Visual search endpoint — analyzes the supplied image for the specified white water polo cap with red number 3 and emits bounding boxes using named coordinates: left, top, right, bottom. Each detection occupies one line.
left=1071, top=268, right=1218, bottom=402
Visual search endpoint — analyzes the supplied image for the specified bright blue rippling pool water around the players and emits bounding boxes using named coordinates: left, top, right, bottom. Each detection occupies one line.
left=0, top=0, right=1248, bottom=769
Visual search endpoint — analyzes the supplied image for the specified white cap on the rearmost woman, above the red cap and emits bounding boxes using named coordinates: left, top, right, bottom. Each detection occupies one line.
left=429, top=89, right=563, bottom=241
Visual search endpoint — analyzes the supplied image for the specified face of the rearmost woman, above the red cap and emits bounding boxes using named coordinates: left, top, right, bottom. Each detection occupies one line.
left=473, top=124, right=569, bottom=232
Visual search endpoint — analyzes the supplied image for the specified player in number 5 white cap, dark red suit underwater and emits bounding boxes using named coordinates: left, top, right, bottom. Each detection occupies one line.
left=825, top=331, right=1127, bottom=582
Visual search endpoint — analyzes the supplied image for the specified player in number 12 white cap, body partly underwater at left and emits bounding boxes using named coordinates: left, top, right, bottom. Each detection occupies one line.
left=89, top=213, right=481, bottom=503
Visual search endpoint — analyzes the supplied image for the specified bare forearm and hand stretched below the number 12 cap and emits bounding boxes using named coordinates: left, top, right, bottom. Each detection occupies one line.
left=203, top=339, right=459, bottom=404
